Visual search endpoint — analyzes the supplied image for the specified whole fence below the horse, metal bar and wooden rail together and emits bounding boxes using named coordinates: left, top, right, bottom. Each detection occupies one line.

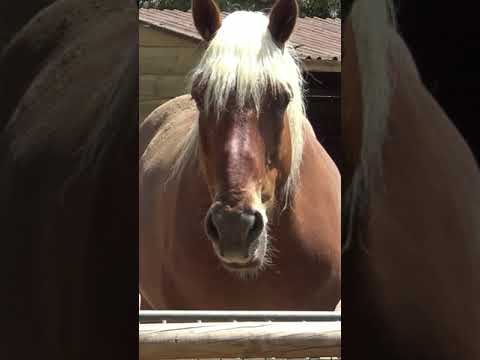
left=139, top=311, right=341, bottom=360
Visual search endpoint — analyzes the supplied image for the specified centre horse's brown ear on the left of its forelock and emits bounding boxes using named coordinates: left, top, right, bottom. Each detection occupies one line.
left=192, top=0, right=222, bottom=41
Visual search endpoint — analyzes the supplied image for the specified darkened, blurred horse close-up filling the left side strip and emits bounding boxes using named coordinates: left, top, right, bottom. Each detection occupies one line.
left=0, top=0, right=138, bottom=359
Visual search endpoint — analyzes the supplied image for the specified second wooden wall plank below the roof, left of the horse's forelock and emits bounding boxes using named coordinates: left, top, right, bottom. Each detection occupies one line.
left=139, top=47, right=203, bottom=76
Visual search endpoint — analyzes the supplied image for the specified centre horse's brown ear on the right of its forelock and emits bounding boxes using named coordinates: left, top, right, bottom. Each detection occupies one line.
left=268, top=0, right=298, bottom=46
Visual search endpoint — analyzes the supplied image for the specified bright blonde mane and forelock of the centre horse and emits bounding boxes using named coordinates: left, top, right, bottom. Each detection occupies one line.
left=167, top=11, right=305, bottom=204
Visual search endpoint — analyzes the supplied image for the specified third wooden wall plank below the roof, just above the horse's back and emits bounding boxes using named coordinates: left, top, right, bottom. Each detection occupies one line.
left=139, top=75, right=188, bottom=101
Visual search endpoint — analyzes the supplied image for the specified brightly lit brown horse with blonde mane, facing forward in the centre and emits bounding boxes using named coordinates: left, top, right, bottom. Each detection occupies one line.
left=139, top=0, right=341, bottom=310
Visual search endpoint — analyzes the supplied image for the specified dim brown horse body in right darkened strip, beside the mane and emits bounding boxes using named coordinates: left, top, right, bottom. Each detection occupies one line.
left=363, top=35, right=480, bottom=355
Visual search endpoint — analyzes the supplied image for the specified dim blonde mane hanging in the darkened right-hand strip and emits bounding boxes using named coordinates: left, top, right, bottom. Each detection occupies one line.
left=342, top=0, right=396, bottom=250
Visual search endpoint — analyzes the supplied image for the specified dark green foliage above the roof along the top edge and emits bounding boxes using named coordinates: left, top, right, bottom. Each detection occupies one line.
left=137, top=0, right=340, bottom=18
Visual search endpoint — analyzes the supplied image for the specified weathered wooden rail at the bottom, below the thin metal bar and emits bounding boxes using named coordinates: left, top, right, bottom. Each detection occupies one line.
left=139, top=321, right=341, bottom=360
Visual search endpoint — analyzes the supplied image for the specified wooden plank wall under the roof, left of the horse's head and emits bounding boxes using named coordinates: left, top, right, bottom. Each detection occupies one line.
left=139, top=24, right=202, bottom=121
